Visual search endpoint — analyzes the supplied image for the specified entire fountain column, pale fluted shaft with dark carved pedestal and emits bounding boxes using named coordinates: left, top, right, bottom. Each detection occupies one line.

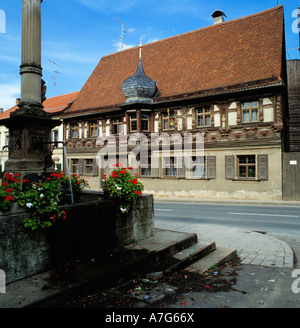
left=2, top=0, right=61, bottom=179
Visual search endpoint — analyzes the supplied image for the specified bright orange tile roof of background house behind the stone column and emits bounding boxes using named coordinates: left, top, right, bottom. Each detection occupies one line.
left=0, top=91, right=79, bottom=120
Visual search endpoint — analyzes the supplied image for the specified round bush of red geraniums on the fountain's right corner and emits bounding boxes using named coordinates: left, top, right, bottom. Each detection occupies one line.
left=103, top=163, right=144, bottom=213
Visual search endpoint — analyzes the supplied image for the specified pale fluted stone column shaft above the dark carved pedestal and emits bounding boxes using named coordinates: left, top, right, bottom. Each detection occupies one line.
left=19, top=0, right=43, bottom=108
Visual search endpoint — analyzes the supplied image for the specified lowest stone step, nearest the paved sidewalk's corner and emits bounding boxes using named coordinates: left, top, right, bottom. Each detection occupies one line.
left=185, top=247, right=237, bottom=273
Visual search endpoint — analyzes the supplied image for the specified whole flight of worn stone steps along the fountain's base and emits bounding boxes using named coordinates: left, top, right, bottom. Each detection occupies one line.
left=0, top=229, right=236, bottom=308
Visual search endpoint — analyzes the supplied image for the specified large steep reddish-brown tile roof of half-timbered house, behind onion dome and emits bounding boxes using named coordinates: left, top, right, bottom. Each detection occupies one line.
left=64, top=6, right=284, bottom=116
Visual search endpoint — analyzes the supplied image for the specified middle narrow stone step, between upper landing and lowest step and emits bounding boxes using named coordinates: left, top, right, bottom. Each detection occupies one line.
left=146, top=240, right=216, bottom=280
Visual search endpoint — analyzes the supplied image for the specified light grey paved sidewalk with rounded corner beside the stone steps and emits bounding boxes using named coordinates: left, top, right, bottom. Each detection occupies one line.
left=155, top=219, right=294, bottom=268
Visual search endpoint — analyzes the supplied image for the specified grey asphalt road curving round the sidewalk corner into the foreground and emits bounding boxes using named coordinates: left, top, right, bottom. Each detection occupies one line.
left=155, top=202, right=300, bottom=308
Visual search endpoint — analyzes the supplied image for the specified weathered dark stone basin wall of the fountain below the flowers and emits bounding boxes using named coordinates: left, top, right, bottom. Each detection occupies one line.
left=0, top=193, right=154, bottom=283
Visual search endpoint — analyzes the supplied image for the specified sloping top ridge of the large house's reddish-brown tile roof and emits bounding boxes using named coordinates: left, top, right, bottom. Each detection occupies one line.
left=100, top=5, right=284, bottom=61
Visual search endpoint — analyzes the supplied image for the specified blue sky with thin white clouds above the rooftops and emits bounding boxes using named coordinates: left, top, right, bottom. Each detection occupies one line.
left=0, top=0, right=300, bottom=110
